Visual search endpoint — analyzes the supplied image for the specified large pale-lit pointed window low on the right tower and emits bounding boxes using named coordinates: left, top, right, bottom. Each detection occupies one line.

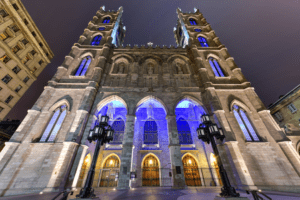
left=232, top=105, right=260, bottom=142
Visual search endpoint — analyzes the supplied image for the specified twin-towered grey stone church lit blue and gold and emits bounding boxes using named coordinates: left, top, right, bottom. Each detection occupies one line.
left=0, top=7, right=300, bottom=196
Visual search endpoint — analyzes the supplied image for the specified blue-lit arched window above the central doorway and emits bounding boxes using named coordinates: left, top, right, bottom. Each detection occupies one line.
left=144, top=119, right=158, bottom=144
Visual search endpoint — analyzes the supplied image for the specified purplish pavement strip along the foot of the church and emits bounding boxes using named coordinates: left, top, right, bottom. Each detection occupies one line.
left=0, top=187, right=300, bottom=200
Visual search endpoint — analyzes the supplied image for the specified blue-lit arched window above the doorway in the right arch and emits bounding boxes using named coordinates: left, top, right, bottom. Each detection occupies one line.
left=177, top=118, right=193, bottom=144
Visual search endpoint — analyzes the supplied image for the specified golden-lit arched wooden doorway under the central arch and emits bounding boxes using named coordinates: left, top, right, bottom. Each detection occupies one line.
left=142, top=155, right=159, bottom=186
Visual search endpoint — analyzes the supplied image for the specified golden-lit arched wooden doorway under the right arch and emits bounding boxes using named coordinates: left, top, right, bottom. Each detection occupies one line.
left=182, top=155, right=201, bottom=186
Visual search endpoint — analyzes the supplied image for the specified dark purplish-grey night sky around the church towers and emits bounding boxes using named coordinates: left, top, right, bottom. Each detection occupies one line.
left=7, top=0, right=300, bottom=120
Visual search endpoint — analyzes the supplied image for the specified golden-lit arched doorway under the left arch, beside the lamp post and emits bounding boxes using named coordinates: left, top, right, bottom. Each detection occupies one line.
left=99, top=155, right=120, bottom=187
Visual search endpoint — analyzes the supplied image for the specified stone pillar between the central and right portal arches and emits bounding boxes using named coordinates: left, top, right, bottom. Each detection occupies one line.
left=166, top=115, right=186, bottom=188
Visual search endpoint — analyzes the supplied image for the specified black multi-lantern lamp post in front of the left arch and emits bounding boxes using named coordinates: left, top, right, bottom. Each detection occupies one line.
left=76, top=115, right=114, bottom=198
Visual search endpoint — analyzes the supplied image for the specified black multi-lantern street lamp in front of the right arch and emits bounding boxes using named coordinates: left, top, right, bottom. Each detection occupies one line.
left=197, top=115, right=240, bottom=197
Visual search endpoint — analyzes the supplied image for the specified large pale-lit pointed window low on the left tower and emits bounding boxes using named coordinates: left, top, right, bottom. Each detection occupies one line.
left=40, top=105, right=67, bottom=142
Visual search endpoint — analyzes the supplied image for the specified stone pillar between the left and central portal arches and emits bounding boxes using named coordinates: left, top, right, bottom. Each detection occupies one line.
left=117, top=115, right=135, bottom=190
